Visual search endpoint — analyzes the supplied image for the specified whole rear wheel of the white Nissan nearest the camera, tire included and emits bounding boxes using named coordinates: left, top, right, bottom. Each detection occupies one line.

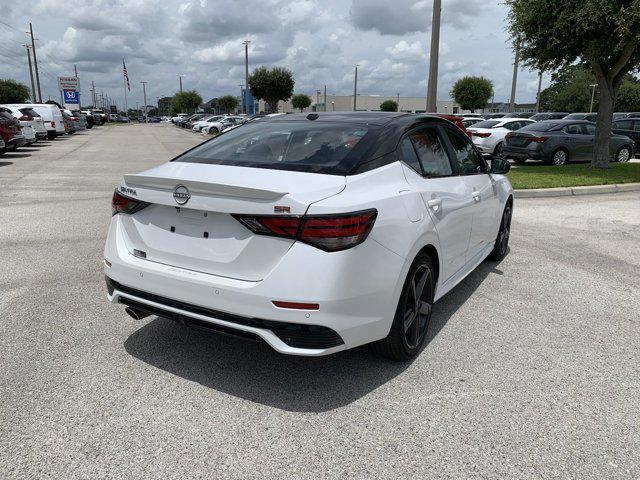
left=372, top=253, right=436, bottom=361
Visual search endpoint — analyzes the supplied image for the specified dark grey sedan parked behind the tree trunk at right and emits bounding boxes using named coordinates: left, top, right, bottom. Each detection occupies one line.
left=502, top=120, right=634, bottom=165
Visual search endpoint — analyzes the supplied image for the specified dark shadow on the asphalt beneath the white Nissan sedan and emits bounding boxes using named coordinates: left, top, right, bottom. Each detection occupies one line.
left=124, top=262, right=502, bottom=412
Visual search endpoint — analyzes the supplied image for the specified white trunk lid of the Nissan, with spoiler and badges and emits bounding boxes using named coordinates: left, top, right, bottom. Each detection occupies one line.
left=119, top=162, right=346, bottom=281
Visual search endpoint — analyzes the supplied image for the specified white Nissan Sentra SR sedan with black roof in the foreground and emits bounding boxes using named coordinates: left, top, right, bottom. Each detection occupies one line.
left=104, top=112, right=513, bottom=360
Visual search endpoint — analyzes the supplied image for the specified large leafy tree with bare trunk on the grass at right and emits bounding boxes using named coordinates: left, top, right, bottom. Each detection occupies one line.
left=505, top=0, right=640, bottom=168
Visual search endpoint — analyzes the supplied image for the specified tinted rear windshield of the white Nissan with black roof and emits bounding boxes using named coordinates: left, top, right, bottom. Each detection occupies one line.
left=174, top=121, right=380, bottom=175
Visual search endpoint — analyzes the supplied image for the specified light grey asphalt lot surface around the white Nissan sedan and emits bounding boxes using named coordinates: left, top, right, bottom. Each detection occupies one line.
left=0, top=124, right=640, bottom=479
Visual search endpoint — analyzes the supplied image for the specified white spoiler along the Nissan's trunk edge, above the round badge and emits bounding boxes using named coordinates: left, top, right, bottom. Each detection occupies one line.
left=124, top=175, right=289, bottom=200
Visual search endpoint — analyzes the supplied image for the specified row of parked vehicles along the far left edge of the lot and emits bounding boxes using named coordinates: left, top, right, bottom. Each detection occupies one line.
left=0, top=103, right=108, bottom=155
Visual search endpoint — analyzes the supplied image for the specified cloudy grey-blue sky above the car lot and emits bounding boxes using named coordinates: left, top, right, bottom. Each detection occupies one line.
left=0, top=0, right=547, bottom=108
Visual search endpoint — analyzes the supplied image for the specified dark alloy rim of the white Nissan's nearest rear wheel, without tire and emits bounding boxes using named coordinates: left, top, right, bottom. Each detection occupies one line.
left=403, top=264, right=433, bottom=348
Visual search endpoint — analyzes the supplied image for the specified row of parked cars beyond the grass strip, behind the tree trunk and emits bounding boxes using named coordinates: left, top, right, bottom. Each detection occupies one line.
left=444, top=112, right=640, bottom=165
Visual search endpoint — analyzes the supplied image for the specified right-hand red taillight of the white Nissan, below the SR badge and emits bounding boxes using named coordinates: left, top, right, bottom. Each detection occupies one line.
left=234, top=209, right=378, bottom=252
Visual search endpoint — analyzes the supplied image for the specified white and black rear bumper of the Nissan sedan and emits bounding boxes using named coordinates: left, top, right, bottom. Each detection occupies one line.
left=104, top=215, right=405, bottom=356
